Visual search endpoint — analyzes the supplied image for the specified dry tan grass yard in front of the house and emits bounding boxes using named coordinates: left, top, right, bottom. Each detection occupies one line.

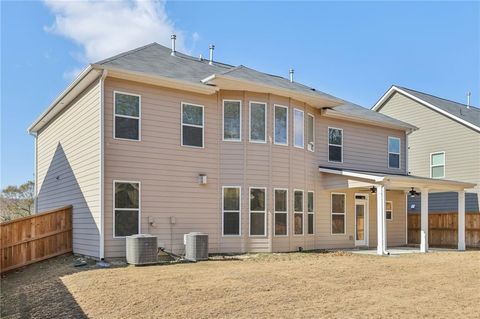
left=1, top=251, right=480, bottom=318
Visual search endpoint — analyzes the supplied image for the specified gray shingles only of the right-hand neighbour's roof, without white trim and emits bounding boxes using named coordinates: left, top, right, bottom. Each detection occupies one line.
left=396, top=85, right=480, bottom=127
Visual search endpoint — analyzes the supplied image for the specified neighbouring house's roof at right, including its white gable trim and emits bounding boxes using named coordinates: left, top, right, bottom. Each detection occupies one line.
left=372, top=85, right=480, bottom=131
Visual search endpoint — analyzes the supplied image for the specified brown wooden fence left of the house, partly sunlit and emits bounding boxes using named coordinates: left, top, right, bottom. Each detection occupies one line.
left=0, top=206, right=72, bottom=272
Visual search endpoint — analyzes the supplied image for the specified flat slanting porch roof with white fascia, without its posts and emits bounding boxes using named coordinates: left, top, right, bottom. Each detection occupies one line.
left=319, top=166, right=475, bottom=192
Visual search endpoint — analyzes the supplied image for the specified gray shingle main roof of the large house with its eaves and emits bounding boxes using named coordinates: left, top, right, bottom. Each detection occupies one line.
left=28, top=43, right=415, bottom=133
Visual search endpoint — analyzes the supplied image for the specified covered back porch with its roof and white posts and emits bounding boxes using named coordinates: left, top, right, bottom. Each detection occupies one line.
left=319, top=167, right=474, bottom=255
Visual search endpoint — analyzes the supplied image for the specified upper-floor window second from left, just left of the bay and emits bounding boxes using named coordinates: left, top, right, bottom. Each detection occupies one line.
left=182, top=103, right=204, bottom=147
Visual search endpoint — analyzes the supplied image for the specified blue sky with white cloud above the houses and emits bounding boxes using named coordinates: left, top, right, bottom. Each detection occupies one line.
left=1, top=1, right=480, bottom=187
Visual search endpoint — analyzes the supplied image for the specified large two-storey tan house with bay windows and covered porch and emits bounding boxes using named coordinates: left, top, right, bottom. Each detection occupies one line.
left=29, top=43, right=473, bottom=258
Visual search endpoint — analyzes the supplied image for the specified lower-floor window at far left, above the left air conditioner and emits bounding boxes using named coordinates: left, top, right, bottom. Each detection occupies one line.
left=113, top=181, right=140, bottom=237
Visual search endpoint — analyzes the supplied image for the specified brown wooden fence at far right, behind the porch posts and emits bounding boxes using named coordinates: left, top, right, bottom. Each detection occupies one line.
left=408, top=213, right=480, bottom=248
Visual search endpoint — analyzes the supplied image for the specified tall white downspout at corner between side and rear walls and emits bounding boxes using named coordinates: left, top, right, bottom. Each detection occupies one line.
left=99, top=70, right=108, bottom=260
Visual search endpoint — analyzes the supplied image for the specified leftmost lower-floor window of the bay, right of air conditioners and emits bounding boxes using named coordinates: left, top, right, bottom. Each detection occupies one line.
left=222, top=186, right=241, bottom=236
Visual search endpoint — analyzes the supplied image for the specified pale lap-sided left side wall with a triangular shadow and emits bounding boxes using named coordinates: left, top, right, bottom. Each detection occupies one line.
left=36, top=81, right=101, bottom=257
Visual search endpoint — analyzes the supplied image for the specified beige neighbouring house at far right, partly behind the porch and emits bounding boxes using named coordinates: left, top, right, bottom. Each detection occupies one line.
left=373, top=86, right=480, bottom=212
